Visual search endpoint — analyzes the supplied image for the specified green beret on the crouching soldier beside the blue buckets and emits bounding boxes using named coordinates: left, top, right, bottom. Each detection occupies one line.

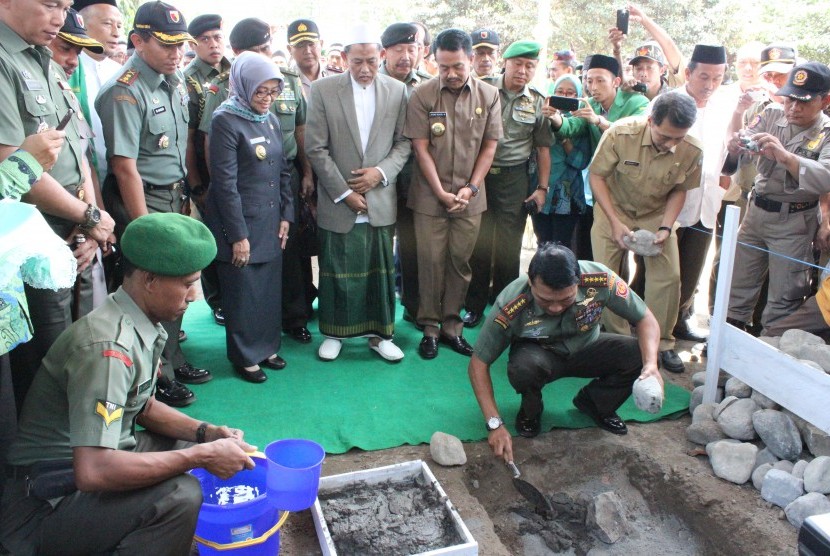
left=121, top=212, right=216, bottom=276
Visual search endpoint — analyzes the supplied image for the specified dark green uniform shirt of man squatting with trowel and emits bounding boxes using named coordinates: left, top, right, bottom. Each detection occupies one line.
left=474, top=261, right=646, bottom=365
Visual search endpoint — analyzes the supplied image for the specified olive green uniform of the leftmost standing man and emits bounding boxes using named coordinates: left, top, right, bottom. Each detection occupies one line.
left=0, top=21, right=92, bottom=410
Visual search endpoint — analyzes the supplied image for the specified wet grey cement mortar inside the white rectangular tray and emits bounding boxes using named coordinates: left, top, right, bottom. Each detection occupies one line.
left=319, top=477, right=464, bottom=555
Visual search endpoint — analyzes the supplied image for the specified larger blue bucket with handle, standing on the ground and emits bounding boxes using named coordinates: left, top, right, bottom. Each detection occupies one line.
left=190, top=458, right=288, bottom=556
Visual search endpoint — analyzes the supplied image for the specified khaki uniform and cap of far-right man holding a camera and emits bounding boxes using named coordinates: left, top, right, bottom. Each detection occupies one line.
left=728, top=62, right=830, bottom=328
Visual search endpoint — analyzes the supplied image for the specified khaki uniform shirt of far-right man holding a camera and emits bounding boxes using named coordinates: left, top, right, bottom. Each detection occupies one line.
left=740, top=104, right=830, bottom=203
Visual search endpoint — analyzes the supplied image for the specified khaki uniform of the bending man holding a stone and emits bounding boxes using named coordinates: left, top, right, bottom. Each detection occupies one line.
left=590, top=118, right=703, bottom=351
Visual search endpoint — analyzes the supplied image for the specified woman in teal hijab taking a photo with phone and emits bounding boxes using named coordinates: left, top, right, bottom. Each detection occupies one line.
left=533, top=74, right=592, bottom=260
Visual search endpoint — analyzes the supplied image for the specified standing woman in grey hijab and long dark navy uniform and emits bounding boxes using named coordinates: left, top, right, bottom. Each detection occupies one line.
left=205, top=52, right=294, bottom=382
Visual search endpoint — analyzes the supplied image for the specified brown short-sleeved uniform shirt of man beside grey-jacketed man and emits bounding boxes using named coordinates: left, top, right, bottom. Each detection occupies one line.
left=403, top=78, right=502, bottom=218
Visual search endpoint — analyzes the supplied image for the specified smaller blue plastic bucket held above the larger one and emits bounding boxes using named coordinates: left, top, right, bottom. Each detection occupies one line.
left=265, top=438, right=326, bottom=512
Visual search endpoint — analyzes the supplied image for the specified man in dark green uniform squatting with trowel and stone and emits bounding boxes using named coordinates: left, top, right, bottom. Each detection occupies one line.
left=468, top=243, right=663, bottom=462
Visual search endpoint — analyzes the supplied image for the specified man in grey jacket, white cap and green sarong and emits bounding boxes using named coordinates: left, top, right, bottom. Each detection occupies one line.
left=305, top=25, right=410, bottom=361
